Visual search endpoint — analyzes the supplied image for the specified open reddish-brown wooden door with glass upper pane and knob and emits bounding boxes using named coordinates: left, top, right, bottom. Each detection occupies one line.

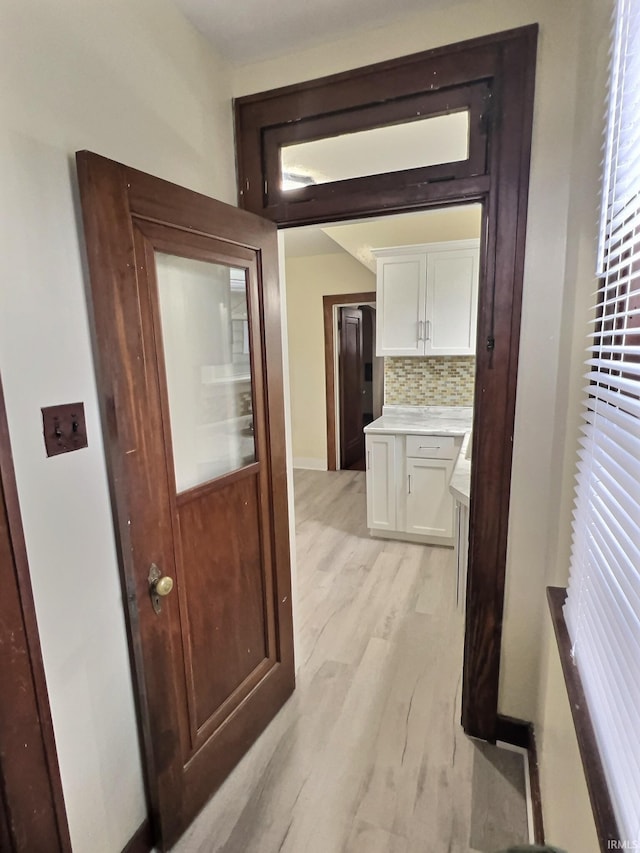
left=78, top=152, right=294, bottom=848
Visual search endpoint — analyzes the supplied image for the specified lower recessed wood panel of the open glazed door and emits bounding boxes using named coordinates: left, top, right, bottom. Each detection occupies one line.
left=178, top=474, right=268, bottom=735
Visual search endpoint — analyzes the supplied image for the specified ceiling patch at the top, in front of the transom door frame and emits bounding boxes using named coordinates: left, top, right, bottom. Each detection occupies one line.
left=174, top=0, right=451, bottom=64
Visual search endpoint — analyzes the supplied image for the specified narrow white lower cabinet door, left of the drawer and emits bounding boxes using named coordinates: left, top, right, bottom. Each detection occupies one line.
left=366, top=435, right=396, bottom=530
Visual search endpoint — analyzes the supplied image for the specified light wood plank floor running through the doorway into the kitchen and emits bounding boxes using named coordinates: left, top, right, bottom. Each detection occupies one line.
left=174, top=471, right=527, bottom=853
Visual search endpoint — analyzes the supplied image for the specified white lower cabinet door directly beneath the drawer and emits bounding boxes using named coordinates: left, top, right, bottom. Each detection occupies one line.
left=405, top=458, right=453, bottom=539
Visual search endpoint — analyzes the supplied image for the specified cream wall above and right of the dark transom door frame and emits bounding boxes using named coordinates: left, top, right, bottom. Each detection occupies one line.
left=233, top=0, right=606, bottom=853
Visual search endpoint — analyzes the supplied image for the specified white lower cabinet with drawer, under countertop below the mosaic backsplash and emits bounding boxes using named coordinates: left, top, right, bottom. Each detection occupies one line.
left=366, top=433, right=461, bottom=546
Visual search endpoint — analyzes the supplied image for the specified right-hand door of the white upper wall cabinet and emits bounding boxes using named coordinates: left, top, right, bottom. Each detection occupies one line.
left=425, top=249, right=478, bottom=355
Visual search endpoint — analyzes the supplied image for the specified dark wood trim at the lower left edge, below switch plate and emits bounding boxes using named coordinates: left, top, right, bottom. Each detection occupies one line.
left=0, top=376, right=71, bottom=853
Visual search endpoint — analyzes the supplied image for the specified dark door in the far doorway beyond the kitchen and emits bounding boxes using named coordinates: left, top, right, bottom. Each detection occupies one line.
left=338, top=308, right=364, bottom=468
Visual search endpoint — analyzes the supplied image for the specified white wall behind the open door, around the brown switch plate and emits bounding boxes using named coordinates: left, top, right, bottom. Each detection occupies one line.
left=0, top=0, right=235, bottom=853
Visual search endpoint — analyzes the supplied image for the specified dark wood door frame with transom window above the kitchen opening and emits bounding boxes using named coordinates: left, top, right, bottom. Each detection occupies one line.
left=236, top=25, right=538, bottom=741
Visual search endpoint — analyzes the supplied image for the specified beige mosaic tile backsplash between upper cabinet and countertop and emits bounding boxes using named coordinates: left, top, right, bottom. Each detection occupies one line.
left=384, top=356, right=476, bottom=406
